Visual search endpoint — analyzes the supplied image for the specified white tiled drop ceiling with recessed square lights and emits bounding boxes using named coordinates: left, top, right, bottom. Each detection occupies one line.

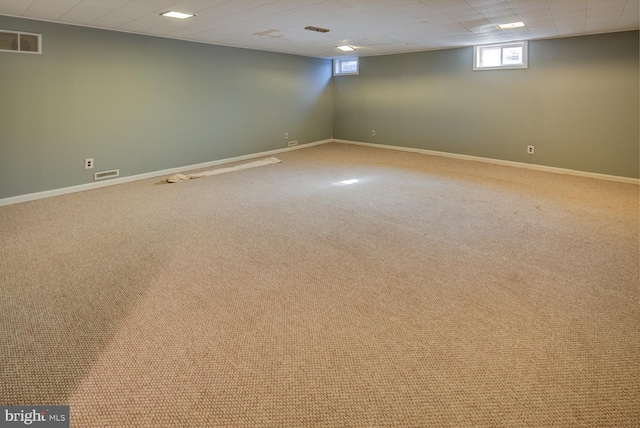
left=0, top=0, right=640, bottom=58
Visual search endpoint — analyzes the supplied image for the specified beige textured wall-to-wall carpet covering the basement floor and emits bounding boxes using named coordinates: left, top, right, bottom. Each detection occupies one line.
left=0, top=144, right=640, bottom=428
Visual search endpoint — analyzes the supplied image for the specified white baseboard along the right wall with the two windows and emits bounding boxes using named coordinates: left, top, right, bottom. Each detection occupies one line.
left=333, top=139, right=640, bottom=185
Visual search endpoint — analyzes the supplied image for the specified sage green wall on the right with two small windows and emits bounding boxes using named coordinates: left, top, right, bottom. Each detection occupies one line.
left=334, top=31, right=640, bottom=178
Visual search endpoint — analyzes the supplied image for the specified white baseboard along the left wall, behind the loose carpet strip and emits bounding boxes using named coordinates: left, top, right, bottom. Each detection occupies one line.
left=0, top=140, right=333, bottom=207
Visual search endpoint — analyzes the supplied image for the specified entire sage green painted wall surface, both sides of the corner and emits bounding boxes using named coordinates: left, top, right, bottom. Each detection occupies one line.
left=0, top=16, right=640, bottom=199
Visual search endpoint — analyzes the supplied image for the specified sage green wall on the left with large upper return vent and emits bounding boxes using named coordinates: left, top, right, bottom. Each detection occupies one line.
left=0, top=16, right=333, bottom=198
